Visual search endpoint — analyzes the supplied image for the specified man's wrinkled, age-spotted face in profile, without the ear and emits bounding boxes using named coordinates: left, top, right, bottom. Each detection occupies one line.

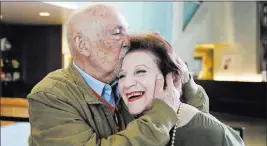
left=84, top=11, right=130, bottom=78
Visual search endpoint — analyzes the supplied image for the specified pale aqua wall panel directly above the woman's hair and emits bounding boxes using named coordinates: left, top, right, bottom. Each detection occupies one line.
left=110, top=2, right=173, bottom=42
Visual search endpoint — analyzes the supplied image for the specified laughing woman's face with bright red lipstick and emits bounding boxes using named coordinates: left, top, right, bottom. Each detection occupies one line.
left=119, top=51, right=160, bottom=115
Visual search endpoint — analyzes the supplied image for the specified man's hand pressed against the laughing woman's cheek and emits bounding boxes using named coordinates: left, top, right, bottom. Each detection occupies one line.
left=154, top=73, right=181, bottom=112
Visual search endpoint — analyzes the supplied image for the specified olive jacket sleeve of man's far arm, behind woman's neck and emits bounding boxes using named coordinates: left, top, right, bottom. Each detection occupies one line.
left=183, top=75, right=209, bottom=113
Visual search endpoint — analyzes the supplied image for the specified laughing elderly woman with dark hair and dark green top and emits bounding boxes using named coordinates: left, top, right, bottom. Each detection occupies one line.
left=119, top=34, right=244, bottom=146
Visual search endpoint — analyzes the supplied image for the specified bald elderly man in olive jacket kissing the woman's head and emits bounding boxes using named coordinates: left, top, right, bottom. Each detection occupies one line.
left=28, top=4, right=208, bottom=146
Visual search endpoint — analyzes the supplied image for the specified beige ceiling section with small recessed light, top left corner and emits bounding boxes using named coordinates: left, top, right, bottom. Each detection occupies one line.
left=1, top=2, right=73, bottom=25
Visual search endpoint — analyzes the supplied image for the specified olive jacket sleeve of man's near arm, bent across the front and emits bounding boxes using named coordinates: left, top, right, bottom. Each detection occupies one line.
left=28, top=92, right=178, bottom=146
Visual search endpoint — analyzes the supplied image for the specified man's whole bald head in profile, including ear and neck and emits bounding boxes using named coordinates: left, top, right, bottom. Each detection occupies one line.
left=67, top=4, right=130, bottom=82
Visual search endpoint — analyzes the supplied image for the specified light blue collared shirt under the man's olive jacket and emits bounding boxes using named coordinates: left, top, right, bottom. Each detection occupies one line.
left=73, top=62, right=119, bottom=107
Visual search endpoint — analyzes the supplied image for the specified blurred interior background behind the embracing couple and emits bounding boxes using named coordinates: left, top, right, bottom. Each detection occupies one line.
left=0, top=1, right=267, bottom=146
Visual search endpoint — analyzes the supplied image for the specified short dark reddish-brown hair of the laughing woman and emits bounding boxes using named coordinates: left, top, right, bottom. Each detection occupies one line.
left=127, top=34, right=182, bottom=88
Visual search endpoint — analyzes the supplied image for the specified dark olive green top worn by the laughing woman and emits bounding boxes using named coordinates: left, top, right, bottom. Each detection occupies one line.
left=169, top=112, right=244, bottom=146
